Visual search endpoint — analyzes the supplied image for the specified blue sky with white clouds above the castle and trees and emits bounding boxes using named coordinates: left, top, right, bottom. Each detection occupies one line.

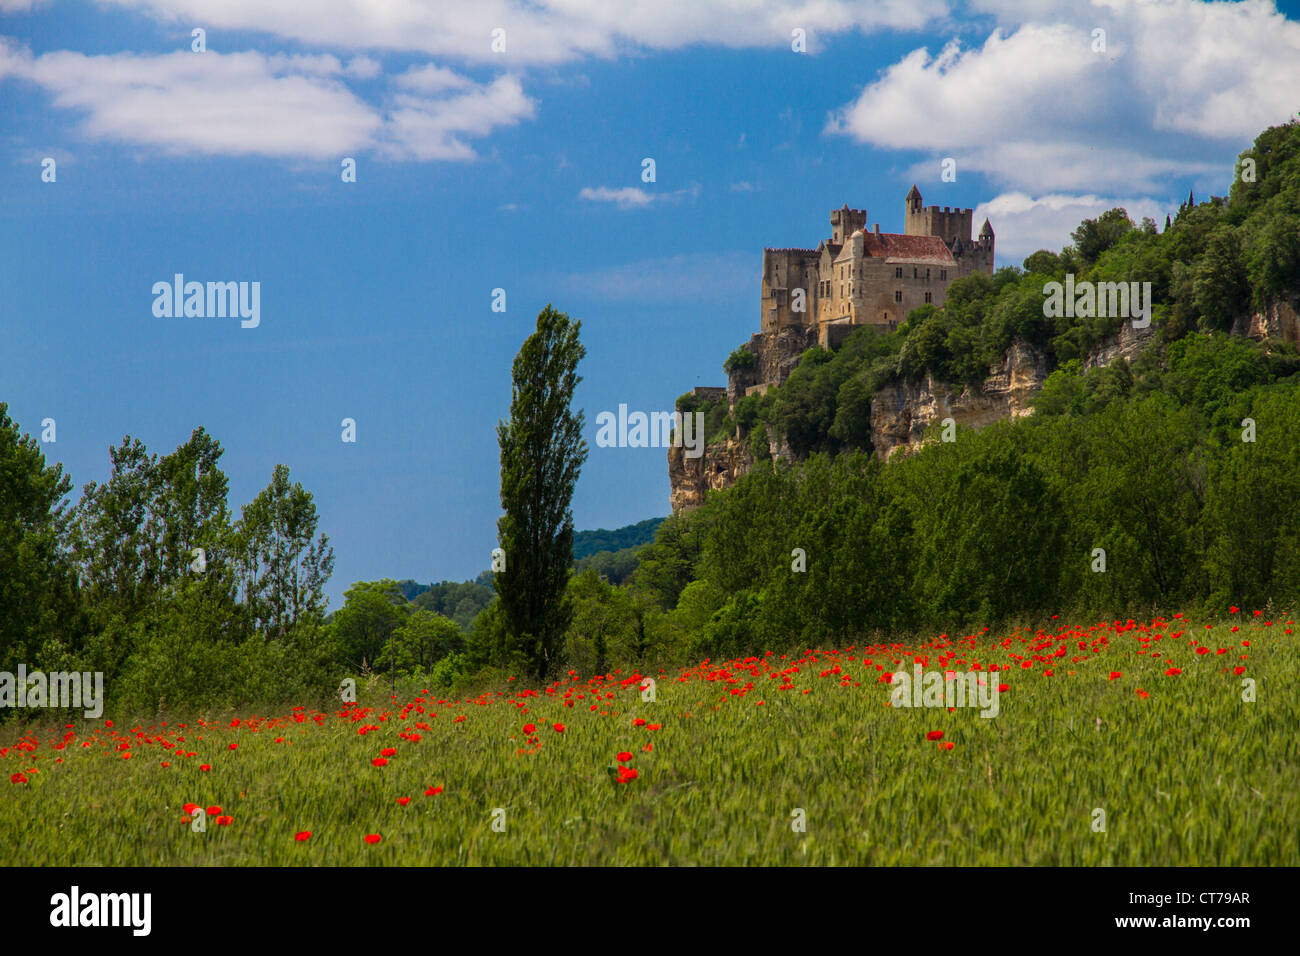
left=0, top=0, right=1300, bottom=606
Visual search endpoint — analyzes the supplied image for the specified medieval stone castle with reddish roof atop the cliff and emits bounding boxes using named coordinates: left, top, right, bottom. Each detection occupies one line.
left=762, top=186, right=993, bottom=349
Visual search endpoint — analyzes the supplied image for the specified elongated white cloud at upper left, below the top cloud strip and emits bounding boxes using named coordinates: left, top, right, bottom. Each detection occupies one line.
left=0, top=38, right=536, bottom=160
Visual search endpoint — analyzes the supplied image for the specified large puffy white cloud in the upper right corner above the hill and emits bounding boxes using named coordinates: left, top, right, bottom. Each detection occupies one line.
left=827, top=0, right=1300, bottom=195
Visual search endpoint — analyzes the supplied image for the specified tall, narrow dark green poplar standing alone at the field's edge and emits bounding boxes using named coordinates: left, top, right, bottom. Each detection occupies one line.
left=495, top=306, right=586, bottom=680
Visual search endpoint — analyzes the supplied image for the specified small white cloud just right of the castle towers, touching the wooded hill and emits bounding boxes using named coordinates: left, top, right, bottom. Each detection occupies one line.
left=972, top=193, right=1177, bottom=265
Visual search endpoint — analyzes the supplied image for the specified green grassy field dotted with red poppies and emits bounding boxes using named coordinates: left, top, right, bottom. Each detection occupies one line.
left=0, top=609, right=1300, bottom=866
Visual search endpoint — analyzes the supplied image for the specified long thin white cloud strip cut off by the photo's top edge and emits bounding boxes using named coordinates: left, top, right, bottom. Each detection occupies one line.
left=91, top=0, right=948, bottom=69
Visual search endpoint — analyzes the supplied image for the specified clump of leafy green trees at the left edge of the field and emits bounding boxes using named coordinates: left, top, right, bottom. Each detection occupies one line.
left=0, top=416, right=339, bottom=715
